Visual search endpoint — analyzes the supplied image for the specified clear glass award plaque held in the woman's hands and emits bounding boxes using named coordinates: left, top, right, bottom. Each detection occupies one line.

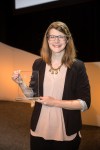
left=16, top=71, right=39, bottom=101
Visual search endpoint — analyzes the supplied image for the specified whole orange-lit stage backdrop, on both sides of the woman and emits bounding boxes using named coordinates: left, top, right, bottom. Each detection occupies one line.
left=0, top=43, right=100, bottom=126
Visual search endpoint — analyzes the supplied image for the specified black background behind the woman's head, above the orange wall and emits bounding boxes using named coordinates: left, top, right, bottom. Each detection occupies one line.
left=0, top=0, right=100, bottom=62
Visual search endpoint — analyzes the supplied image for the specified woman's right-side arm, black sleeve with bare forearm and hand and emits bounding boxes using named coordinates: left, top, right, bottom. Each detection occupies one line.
left=38, top=62, right=91, bottom=111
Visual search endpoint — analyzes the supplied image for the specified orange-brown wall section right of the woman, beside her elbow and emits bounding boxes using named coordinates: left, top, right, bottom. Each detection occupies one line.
left=82, top=62, right=100, bottom=126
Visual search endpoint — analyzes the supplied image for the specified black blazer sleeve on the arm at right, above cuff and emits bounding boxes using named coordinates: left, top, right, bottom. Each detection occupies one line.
left=76, top=61, right=91, bottom=108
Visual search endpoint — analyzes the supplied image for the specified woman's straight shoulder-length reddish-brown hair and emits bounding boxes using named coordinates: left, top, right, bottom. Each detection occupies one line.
left=40, top=21, right=76, bottom=67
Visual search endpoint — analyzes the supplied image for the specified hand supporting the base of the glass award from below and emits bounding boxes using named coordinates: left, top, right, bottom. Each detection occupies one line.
left=36, top=96, right=57, bottom=106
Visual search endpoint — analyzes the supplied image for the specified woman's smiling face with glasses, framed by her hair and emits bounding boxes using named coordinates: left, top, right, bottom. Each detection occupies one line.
left=48, top=29, right=67, bottom=53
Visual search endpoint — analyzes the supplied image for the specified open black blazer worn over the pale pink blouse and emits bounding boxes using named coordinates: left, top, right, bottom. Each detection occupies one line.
left=30, top=58, right=91, bottom=135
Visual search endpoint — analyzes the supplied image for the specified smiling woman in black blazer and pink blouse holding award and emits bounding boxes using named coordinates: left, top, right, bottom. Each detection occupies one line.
left=12, top=21, right=91, bottom=150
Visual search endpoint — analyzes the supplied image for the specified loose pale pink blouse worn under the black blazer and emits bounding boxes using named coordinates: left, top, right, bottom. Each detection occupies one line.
left=30, top=65, right=76, bottom=141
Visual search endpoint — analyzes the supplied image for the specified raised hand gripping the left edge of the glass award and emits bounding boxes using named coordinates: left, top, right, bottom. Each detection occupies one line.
left=12, top=70, right=22, bottom=84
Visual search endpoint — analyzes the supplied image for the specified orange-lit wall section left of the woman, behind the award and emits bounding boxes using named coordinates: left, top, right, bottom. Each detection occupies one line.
left=0, top=43, right=39, bottom=100
